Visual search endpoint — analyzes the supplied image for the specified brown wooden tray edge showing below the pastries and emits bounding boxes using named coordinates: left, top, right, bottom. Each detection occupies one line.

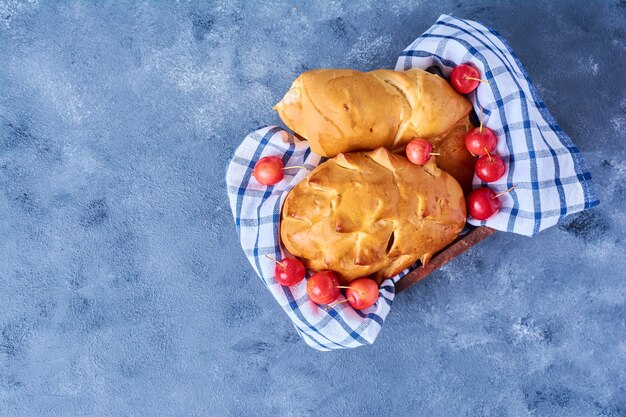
left=396, top=226, right=496, bottom=293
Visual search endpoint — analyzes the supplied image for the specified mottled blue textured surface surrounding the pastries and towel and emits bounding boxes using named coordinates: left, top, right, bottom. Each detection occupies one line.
left=0, top=0, right=626, bottom=417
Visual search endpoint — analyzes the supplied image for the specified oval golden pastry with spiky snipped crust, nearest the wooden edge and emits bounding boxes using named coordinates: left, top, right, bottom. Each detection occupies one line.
left=280, top=148, right=465, bottom=282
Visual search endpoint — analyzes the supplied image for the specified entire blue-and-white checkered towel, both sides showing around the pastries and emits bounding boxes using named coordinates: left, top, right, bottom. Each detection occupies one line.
left=226, top=15, right=598, bottom=350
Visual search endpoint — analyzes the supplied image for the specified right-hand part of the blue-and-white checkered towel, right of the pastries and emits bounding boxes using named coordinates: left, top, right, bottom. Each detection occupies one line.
left=396, top=15, right=599, bottom=236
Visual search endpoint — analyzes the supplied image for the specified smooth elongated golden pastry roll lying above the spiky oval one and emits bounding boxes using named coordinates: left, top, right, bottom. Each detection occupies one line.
left=274, top=68, right=472, bottom=157
